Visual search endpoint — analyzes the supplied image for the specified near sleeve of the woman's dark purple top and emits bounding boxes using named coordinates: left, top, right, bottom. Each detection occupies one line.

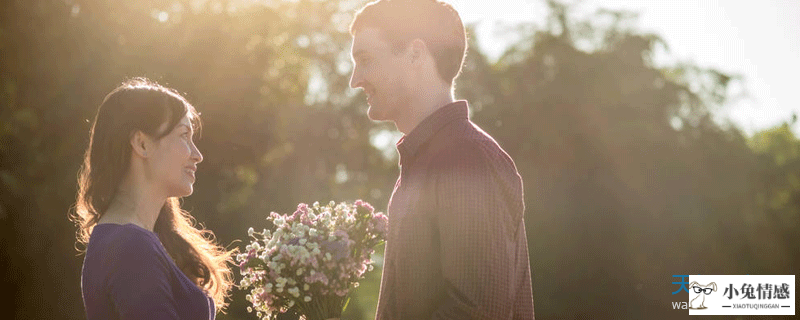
left=107, top=235, right=178, bottom=320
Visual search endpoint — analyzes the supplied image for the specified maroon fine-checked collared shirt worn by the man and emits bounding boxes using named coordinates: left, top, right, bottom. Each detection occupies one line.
left=376, top=101, right=534, bottom=320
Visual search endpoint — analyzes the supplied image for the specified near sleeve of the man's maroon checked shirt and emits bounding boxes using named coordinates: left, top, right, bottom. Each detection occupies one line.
left=433, top=145, right=522, bottom=319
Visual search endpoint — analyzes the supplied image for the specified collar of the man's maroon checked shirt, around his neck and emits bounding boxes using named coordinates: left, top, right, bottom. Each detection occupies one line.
left=397, top=100, right=469, bottom=162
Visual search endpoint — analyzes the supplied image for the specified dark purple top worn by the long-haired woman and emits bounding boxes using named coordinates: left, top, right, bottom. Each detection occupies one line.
left=81, top=223, right=216, bottom=320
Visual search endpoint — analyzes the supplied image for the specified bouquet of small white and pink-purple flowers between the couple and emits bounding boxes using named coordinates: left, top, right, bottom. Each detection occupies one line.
left=236, top=200, right=388, bottom=320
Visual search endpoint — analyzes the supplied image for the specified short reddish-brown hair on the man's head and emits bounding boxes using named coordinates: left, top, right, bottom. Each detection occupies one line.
left=350, top=0, right=467, bottom=85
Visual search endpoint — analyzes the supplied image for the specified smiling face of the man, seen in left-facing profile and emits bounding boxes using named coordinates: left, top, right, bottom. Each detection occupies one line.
left=350, top=28, right=410, bottom=121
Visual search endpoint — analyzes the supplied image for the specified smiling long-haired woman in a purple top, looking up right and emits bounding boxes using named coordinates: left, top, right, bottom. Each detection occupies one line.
left=74, top=78, right=232, bottom=320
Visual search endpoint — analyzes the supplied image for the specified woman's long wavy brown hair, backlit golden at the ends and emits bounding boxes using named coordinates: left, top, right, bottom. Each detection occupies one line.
left=72, top=78, right=233, bottom=310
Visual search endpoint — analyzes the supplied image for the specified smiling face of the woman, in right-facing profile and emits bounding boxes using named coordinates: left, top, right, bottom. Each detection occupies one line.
left=150, top=114, right=203, bottom=197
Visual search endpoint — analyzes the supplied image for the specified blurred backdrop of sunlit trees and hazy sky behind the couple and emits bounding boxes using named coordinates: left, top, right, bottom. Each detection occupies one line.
left=0, top=0, right=800, bottom=319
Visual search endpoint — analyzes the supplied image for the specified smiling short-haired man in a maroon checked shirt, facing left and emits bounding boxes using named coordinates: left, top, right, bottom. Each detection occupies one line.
left=350, top=0, right=533, bottom=320
